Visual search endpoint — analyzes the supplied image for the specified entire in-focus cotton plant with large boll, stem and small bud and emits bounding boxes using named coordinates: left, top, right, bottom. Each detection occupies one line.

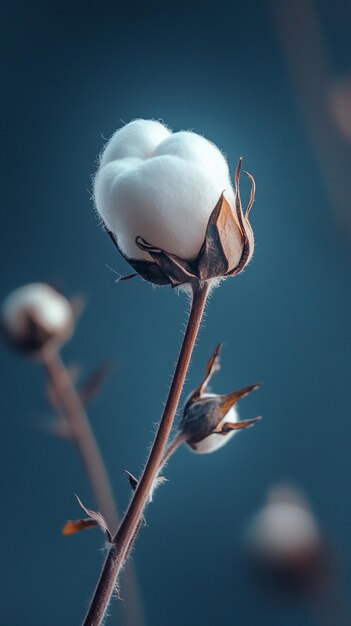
left=69, top=119, right=262, bottom=626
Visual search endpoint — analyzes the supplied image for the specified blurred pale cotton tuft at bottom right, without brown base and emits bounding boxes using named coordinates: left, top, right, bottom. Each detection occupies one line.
left=249, top=487, right=321, bottom=569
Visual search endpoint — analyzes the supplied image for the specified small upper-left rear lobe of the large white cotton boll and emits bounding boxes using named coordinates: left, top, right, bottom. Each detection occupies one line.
left=100, top=119, right=171, bottom=167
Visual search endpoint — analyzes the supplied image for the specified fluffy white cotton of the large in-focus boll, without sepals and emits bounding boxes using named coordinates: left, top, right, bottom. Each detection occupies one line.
left=94, top=119, right=243, bottom=264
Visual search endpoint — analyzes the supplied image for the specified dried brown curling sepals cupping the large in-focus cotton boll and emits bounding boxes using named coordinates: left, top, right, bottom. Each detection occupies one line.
left=104, top=158, right=255, bottom=287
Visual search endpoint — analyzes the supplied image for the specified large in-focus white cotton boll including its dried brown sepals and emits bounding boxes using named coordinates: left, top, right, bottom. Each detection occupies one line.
left=94, top=119, right=253, bottom=285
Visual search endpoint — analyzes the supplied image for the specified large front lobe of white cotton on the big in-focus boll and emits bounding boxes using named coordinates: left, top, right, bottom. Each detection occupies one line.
left=100, top=155, right=238, bottom=259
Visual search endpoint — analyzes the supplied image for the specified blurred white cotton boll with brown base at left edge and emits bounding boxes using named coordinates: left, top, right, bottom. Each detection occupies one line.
left=1, top=283, right=73, bottom=353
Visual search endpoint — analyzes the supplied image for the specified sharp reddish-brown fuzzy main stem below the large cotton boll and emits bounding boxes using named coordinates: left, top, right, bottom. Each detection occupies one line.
left=83, top=283, right=209, bottom=626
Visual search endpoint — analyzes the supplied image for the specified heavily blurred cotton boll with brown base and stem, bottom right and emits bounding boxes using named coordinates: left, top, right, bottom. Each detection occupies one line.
left=245, top=483, right=340, bottom=624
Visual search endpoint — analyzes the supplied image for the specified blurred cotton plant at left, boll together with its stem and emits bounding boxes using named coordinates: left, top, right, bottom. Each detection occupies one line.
left=0, top=283, right=143, bottom=626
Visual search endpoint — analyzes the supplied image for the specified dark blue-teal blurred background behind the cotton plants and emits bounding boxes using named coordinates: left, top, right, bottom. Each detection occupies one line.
left=0, top=0, right=351, bottom=626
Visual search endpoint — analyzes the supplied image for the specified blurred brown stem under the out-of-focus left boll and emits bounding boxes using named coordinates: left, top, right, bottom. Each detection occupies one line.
left=41, top=350, right=144, bottom=626
